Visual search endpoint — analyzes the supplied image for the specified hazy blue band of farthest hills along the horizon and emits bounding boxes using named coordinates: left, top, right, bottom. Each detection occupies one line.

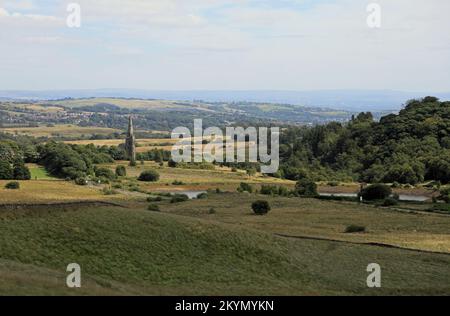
left=0, top=89, right=450, bottom=112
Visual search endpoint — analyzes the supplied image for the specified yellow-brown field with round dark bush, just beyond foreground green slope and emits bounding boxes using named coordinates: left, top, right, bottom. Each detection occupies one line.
left=161, top=193, right=450, bottom=254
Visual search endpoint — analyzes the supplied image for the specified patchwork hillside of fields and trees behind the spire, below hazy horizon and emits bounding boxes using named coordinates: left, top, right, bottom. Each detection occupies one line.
left=0, top=98, right=352, bottom=134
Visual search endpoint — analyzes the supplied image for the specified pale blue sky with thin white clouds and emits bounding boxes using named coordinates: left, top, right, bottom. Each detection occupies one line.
left=0, top=0, right=450, bottom=92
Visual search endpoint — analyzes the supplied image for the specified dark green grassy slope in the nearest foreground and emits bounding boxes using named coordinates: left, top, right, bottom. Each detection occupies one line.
left=0, top=202, right=450, bottom=295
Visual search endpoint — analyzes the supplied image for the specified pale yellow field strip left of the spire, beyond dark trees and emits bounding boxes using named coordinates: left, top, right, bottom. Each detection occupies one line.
left=0, top=125, right=122, bottom=138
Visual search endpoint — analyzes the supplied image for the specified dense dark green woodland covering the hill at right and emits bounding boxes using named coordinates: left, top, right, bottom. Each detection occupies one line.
left=275, top=97, right=450, bottom=185
